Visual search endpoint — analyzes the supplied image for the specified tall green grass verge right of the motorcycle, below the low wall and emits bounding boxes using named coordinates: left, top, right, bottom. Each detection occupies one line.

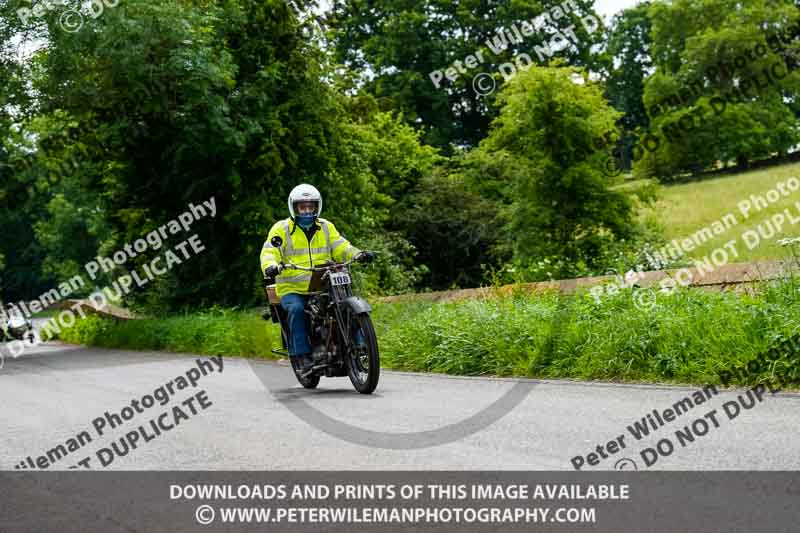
left=376, top=274, right=800, bottom=386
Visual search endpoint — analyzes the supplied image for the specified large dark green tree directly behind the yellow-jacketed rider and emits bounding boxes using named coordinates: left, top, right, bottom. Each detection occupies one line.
left=14, top=0, right=375, bottom=308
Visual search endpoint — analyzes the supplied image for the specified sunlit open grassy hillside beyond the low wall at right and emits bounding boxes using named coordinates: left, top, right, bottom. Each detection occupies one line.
left=645, top=163, right=800, bottom=262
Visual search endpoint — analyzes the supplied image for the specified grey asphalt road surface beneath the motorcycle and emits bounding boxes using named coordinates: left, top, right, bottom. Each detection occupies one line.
left=0, top=336, right=800, bottom=470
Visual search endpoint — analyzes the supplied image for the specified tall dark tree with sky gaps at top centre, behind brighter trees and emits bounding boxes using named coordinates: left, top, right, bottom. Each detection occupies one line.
left=327, top=0, right=602, bottom=154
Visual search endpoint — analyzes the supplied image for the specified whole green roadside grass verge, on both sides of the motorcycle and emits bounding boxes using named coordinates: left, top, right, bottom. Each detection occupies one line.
left=50, top=280, right=800, bottom=386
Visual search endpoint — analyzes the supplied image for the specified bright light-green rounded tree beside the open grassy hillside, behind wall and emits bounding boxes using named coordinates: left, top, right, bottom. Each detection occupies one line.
left=480, top=67, right=636, bottom=275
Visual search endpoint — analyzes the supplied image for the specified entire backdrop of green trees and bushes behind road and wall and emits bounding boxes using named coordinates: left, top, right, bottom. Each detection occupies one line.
left=0, top=0, right=800, bottom=314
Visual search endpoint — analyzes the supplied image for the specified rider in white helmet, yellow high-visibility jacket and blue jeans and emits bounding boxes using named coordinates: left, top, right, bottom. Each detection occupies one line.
left=261, top=183, right=375, bottom=371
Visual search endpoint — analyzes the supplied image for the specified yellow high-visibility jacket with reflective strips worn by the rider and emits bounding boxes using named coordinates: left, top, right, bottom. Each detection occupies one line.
left=261, top=218, right=361, bottom=298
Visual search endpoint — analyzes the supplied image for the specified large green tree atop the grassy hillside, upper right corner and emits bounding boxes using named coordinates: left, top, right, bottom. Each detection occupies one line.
left=636, top=0, right=800, bottom=178
